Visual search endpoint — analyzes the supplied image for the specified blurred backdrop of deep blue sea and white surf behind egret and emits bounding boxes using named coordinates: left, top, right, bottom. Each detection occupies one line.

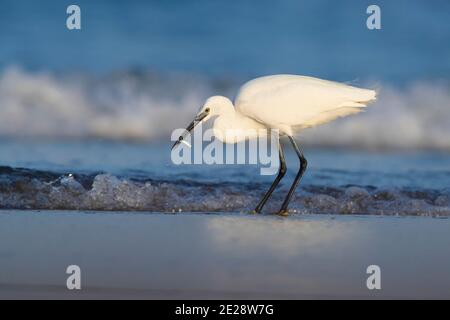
left=0, top=0, right=450, bottom=151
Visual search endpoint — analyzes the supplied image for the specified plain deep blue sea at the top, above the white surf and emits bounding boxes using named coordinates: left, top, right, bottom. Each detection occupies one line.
left=0, top=0, right=450, bottom=83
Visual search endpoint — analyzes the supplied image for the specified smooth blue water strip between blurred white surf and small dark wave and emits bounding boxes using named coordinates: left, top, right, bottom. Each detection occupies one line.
left=0, top=140, right=450, bottom=191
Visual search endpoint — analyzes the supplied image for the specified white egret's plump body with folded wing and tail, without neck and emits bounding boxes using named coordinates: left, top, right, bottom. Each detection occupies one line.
left=235, top=75, right=376, bottom=134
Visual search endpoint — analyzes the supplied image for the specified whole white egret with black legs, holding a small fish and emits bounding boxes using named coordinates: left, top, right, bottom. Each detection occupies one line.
left=172, top=75, right=376, bottom=215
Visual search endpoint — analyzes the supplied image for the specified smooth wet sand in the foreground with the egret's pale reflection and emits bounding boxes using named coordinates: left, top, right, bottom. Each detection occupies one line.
left=0, top=210, right=450, bottom=299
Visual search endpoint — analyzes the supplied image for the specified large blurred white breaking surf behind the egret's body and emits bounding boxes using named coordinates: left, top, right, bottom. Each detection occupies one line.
left=0, top=67, right=450, bottom=151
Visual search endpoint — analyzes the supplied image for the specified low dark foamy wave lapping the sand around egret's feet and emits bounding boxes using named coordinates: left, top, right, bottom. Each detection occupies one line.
left=0, top=167, right=450, bottom=216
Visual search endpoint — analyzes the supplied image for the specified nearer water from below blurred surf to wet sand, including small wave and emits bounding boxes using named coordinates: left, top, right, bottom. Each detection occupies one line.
left=0, top=140, right=450, bottom=216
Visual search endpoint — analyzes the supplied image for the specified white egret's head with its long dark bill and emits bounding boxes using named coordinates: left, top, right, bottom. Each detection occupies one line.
left=172, top=96, right=234, bottom=149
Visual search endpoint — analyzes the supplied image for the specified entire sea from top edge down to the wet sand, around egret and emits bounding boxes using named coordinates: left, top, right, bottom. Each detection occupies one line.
left=0, top=0, right=450, bottom=216
